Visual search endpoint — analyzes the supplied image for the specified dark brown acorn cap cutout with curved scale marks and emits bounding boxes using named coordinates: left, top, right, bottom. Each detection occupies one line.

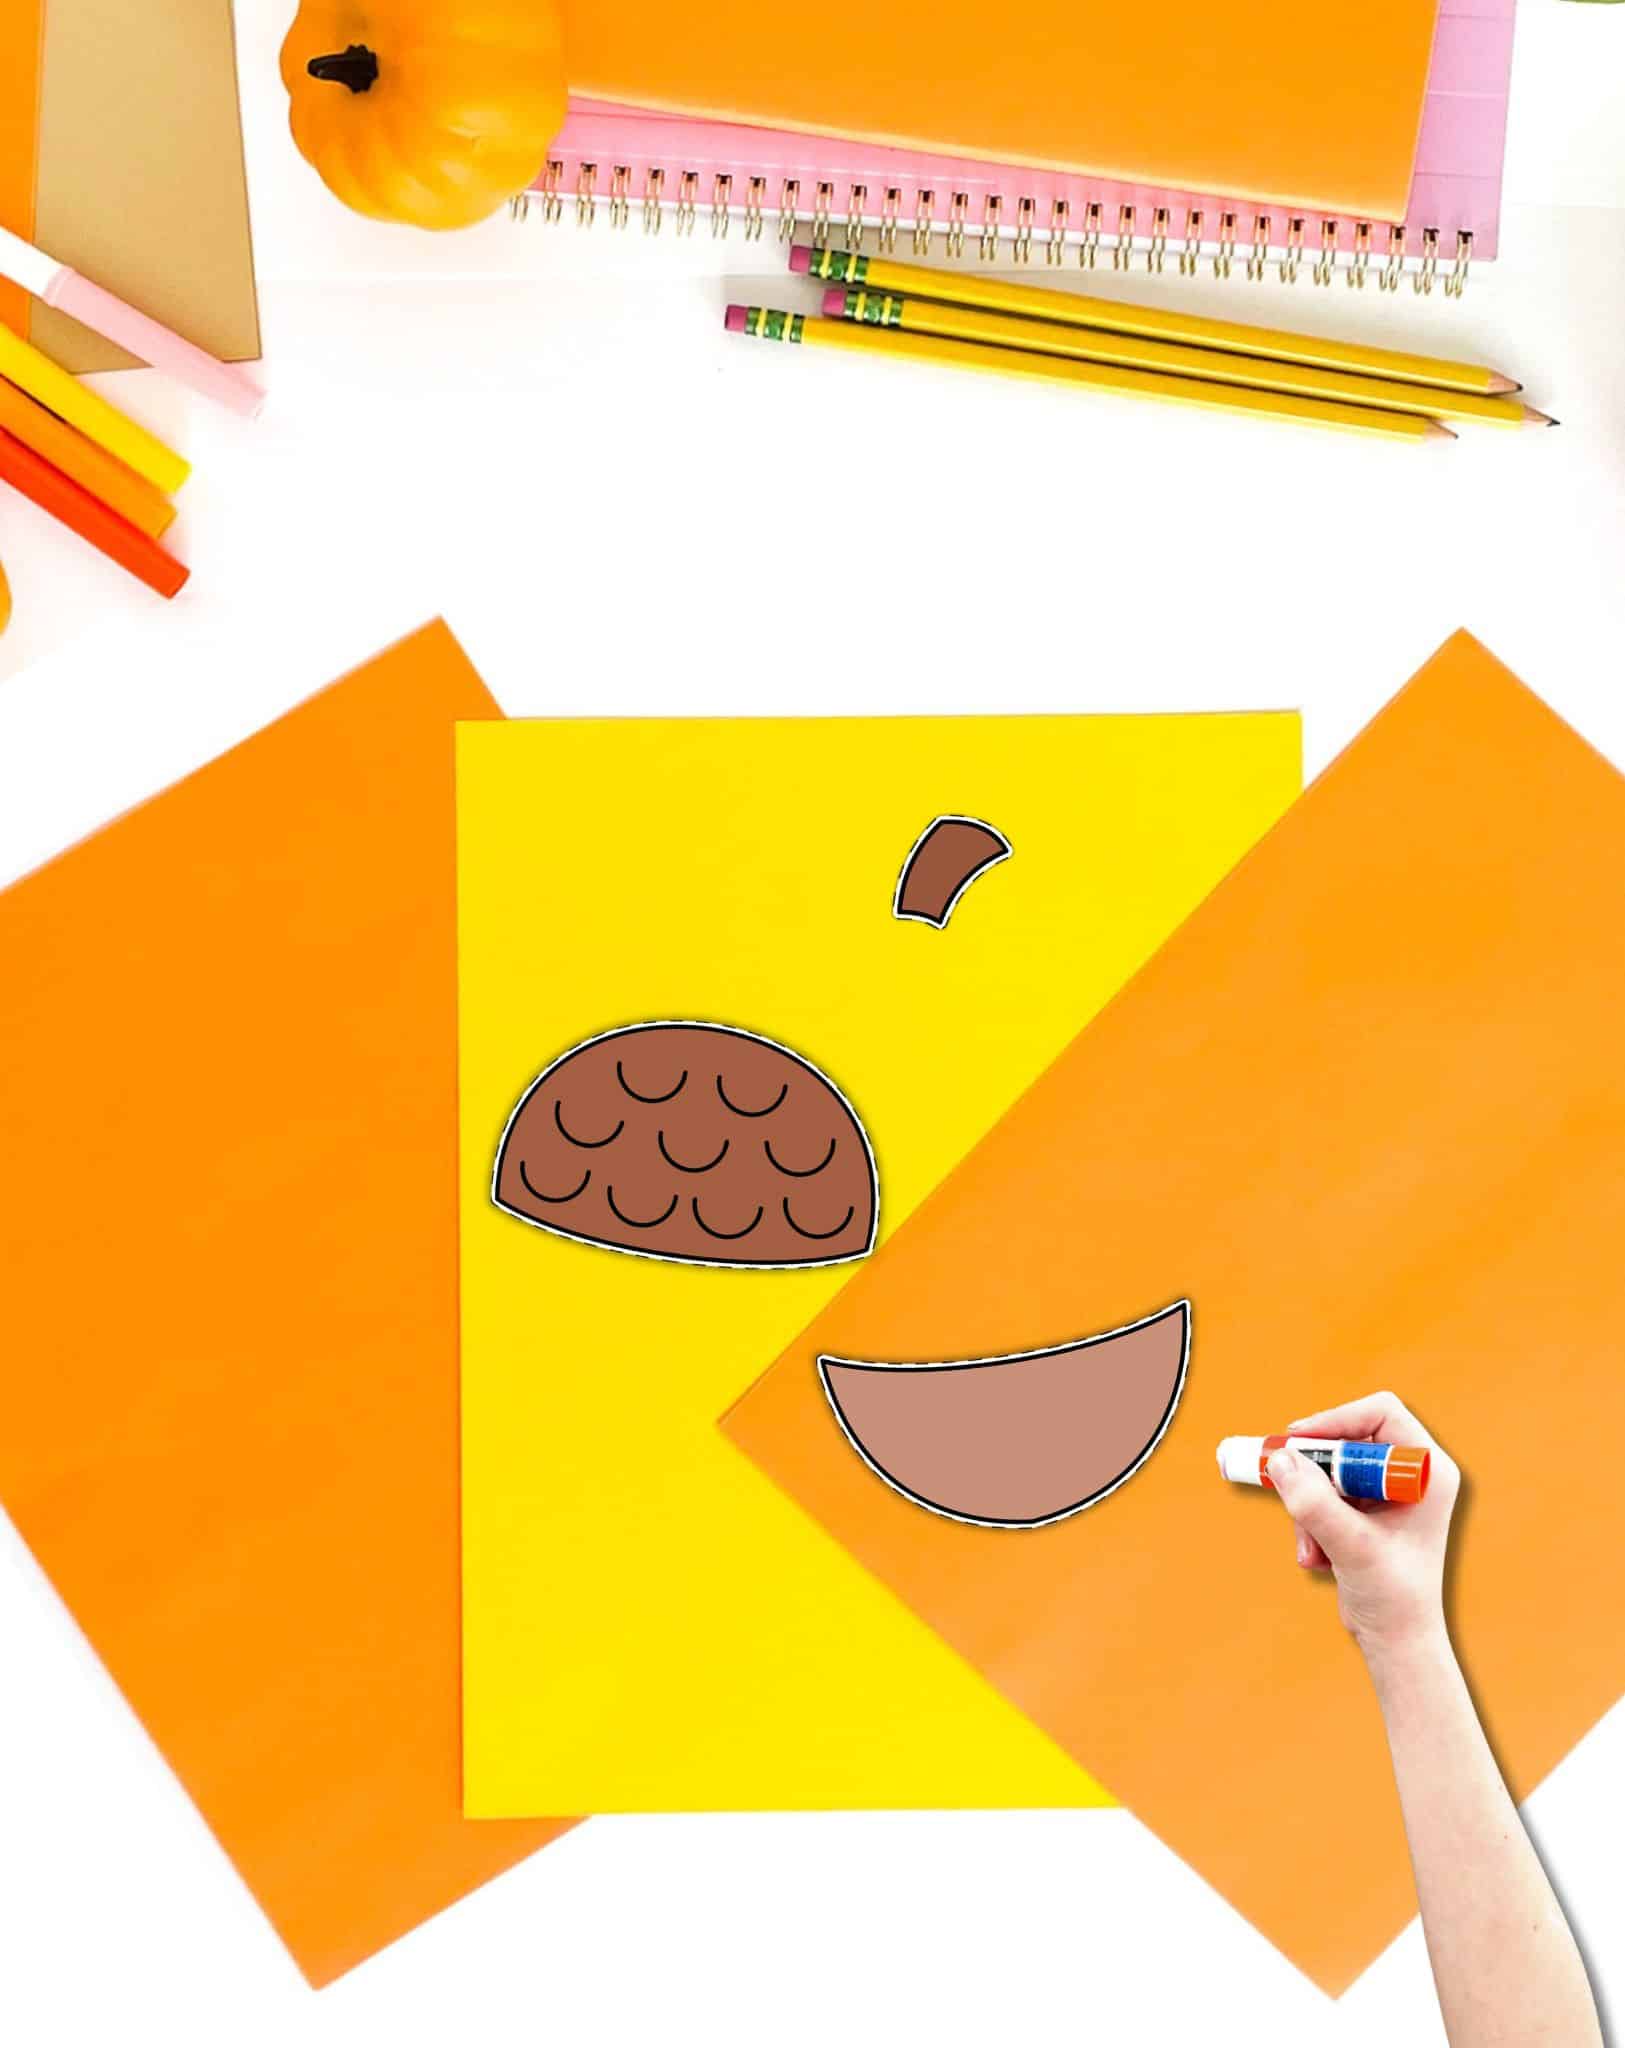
left=492, top=1024, right=879, bottom=1266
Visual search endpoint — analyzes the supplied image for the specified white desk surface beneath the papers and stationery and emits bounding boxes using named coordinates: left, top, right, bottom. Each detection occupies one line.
left=0, top=0, right=1625, bottom=2048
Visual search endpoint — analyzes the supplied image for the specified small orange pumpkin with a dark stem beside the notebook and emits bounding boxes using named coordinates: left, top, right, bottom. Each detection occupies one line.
left=283, top=0, right=566, bottom=227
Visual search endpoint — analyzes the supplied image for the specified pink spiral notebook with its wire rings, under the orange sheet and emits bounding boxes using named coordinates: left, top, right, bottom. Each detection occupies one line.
left=514, top=0, right=1516, bottom=297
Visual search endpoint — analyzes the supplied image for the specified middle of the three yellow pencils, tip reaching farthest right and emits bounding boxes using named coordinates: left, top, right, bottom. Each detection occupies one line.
left=824, top=285, right=1557, bottom=426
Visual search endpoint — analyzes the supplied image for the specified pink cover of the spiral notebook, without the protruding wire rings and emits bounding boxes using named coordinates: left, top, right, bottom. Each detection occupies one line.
left=535, top=0, right=1516, bottom=266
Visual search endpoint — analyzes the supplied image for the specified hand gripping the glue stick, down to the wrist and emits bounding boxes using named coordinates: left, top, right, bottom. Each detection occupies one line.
left=1268, top=1395, right=1461, bottom=1659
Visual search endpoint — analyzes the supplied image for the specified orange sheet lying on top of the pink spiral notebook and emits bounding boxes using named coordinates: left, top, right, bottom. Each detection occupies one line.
left=566, top=0, right=1436, bottom=221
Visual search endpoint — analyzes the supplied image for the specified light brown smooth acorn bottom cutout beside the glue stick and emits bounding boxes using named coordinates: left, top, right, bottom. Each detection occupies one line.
left=818, top=1300, right=1191, bottom=1528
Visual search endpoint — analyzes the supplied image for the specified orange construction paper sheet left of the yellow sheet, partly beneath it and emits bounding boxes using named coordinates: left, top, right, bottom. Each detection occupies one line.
left=0, top=625, right=566, bottom=1985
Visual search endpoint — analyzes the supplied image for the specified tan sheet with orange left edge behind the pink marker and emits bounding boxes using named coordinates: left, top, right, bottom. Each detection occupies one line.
left=0, top=0, right=260, bottom=371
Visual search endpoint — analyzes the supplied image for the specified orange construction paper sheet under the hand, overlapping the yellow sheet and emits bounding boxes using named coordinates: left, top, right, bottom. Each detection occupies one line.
left=723, top=633, right=1625, bottom=1993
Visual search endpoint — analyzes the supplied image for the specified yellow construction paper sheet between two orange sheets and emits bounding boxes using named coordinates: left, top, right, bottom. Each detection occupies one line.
left=457, top=713, right=1299, bottom=1819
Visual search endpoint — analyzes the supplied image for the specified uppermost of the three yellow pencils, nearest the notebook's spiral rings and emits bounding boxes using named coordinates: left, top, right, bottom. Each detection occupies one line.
left=789, top=246, right=1523, bottom=397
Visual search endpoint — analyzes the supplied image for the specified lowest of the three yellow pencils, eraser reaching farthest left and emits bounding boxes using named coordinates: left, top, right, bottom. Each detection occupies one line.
left=727, top=305, right=1455, bottom=440
